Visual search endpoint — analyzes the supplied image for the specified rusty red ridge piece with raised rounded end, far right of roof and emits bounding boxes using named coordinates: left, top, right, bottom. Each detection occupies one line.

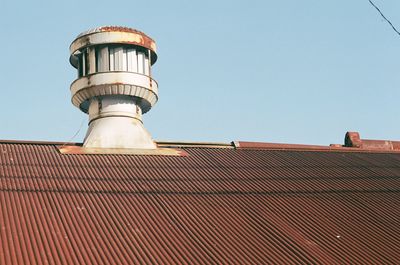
left=344, top=132, right=400, bottom=150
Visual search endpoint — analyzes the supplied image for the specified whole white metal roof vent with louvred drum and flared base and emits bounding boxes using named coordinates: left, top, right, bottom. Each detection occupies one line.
left=70, top=26, right=158, bottom=149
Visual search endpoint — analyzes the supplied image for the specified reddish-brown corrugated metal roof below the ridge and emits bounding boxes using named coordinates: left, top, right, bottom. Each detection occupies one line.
left=0, top=141, right=400, bottom=264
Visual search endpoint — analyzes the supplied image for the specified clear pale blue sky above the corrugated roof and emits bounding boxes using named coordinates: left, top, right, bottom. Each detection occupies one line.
left=0, top=0, right=400, bottom=145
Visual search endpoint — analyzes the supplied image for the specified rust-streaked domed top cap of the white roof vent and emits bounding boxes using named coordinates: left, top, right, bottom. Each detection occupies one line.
left=69, top=26, right=157, bottom=64
